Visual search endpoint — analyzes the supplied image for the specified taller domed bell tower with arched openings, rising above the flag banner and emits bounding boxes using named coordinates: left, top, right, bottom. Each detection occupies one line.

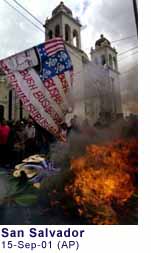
left=44, top=2, right=81, bottom=49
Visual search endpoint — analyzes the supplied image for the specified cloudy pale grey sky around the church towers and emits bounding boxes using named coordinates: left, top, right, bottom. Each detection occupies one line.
left=0, top=0, right=137, bottom=111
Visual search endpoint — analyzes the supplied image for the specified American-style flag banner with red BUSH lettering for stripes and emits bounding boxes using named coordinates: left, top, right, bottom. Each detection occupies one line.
left=0, top=37, right=73, bottom=138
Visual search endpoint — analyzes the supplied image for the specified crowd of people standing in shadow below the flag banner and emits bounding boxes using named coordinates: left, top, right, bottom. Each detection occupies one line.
left=0, top=116, right=82, bottom=168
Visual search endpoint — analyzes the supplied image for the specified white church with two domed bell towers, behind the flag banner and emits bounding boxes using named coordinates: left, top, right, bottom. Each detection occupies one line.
left=0, top=2, right=122, bottom=124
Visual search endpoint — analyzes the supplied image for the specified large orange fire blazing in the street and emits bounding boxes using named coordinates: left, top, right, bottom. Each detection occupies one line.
left=65, top=139, right=137, bottom=224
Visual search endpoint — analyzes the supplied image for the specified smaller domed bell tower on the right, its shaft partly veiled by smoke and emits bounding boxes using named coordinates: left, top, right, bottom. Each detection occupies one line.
left=91, top=34, right=122, bottom=114
